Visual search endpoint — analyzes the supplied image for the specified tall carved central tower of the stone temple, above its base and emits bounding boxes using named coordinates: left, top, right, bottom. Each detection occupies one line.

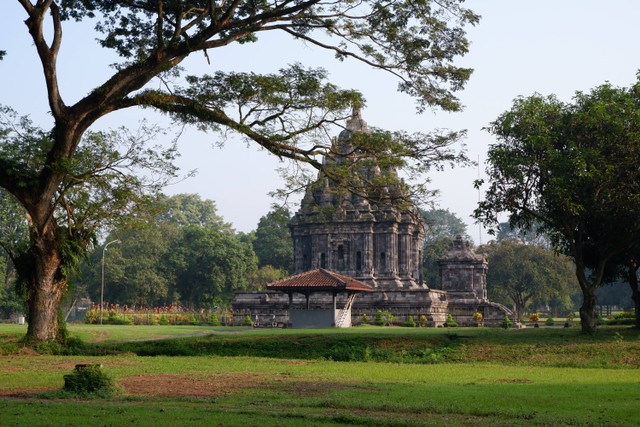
left=290, top=111, right=426, bottom=290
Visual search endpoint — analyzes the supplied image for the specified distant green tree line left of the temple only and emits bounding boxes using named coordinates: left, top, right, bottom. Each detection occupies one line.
left=0, top=193, right=293, bottom=318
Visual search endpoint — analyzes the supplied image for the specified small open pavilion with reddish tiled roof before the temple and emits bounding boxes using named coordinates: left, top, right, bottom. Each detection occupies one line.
left=267, top=268, right=373, bottom=328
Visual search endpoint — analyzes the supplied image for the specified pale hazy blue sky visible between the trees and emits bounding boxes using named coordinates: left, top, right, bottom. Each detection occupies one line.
left=0, top=0, right=640, bottom=243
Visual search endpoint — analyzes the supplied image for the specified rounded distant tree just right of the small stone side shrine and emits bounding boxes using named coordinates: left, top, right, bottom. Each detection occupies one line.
left=482, top=240, right=576, bottom=320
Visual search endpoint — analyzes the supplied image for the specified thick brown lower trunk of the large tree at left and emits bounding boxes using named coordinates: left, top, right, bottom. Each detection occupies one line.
left=22, top=217, right=67, bottom=344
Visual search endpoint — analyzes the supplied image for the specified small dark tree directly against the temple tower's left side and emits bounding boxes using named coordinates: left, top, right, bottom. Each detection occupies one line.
left=253, top=206, right=293, bottom=273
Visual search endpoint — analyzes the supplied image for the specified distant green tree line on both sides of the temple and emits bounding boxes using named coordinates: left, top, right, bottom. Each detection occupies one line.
left=0, top=199, right=633, bottom=318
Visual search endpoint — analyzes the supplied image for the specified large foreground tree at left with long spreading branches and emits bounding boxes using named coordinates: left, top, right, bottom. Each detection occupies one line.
left=5, top=0, right=479, bottom=343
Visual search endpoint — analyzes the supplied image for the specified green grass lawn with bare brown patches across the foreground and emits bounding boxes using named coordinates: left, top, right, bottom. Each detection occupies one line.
left=0, top=325, right=640, bottom=426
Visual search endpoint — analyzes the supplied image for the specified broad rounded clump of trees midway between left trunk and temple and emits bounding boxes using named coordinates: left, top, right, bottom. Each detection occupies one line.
left=80, top=194, right=257, bottom=309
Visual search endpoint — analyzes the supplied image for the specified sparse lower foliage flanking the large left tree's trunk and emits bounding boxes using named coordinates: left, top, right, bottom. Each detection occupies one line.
left=0, top=107, right=182, bottom=288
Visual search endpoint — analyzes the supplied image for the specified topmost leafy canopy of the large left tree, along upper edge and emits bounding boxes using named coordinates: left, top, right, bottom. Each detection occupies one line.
left=55, top=0, right=479, bottom=110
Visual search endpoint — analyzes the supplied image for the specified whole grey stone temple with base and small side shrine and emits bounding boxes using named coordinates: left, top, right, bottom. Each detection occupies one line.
left=233, top=110, right=511, bottom=327
